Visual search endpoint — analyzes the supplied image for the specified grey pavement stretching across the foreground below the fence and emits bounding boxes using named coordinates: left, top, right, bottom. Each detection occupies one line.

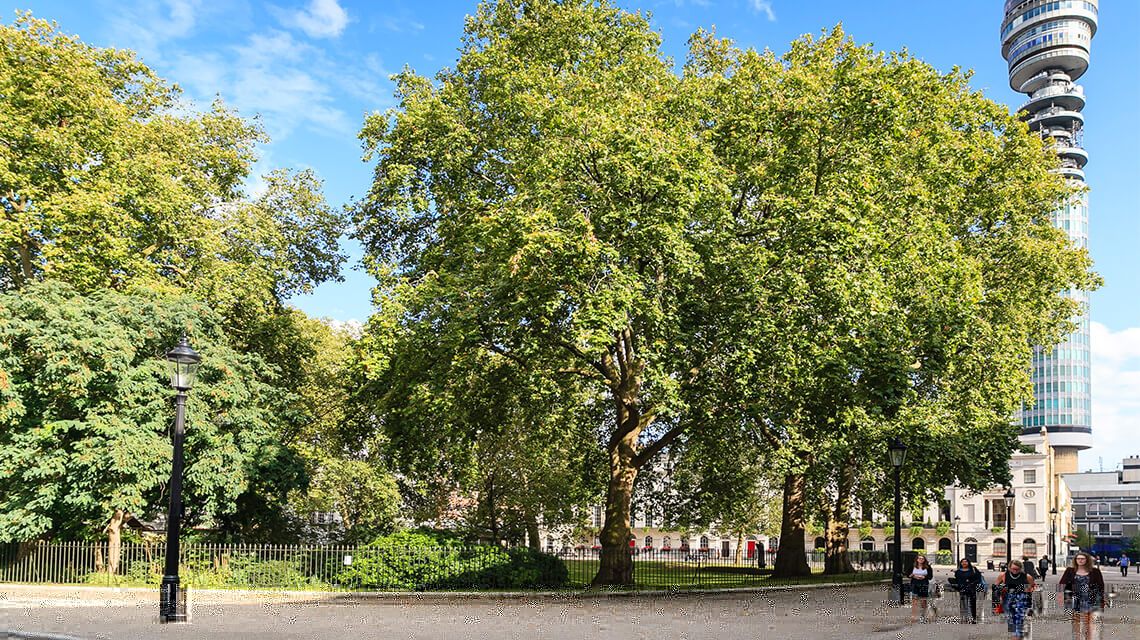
left=0, top=572, right=1140, bottom=640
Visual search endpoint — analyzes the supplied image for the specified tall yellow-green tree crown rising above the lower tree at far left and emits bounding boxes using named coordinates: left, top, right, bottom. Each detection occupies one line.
left=0, top=14, right=344, bottom=309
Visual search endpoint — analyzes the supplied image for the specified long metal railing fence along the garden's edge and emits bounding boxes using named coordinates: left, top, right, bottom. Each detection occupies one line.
left=0, top=542, right=889, bottom=591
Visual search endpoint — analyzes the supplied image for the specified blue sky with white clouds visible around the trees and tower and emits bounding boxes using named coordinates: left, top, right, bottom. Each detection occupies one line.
left=17, top=0, right=1140, bottom=468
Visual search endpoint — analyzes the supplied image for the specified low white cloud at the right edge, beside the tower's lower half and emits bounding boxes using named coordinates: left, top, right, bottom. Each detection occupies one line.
left=1081, top=322, right=1140, bottom=471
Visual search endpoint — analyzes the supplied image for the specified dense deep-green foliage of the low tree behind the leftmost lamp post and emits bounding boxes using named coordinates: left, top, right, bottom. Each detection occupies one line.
left=0, top=282, right=307, bottom=541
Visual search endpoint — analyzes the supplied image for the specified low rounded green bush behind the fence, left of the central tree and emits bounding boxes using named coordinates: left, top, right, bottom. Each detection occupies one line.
left=337, top=532, right=569, bottom=591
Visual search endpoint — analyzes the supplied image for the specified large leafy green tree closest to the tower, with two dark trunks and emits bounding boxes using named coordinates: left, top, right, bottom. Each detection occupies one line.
left=686, top=23, right=1097, bottom=575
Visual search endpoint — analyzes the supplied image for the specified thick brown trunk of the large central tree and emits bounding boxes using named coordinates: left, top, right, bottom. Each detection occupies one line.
left=591, top=428, right=637, bottom=586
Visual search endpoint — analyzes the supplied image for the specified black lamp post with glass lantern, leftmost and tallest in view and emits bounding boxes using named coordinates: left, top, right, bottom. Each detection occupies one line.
left=158, top=334, right=202, bottom=623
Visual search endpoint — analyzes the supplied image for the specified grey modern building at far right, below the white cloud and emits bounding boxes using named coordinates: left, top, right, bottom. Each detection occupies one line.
left=1065, top=456, right=1140, bottom=558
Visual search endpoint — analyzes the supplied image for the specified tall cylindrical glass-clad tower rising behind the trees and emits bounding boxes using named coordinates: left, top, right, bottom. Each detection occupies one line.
left=1001, top=0, right=1098, bottom=451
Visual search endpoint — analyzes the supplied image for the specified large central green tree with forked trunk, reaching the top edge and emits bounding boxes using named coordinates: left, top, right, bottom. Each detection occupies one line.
left=357, top=1, right=725, bottom=584
